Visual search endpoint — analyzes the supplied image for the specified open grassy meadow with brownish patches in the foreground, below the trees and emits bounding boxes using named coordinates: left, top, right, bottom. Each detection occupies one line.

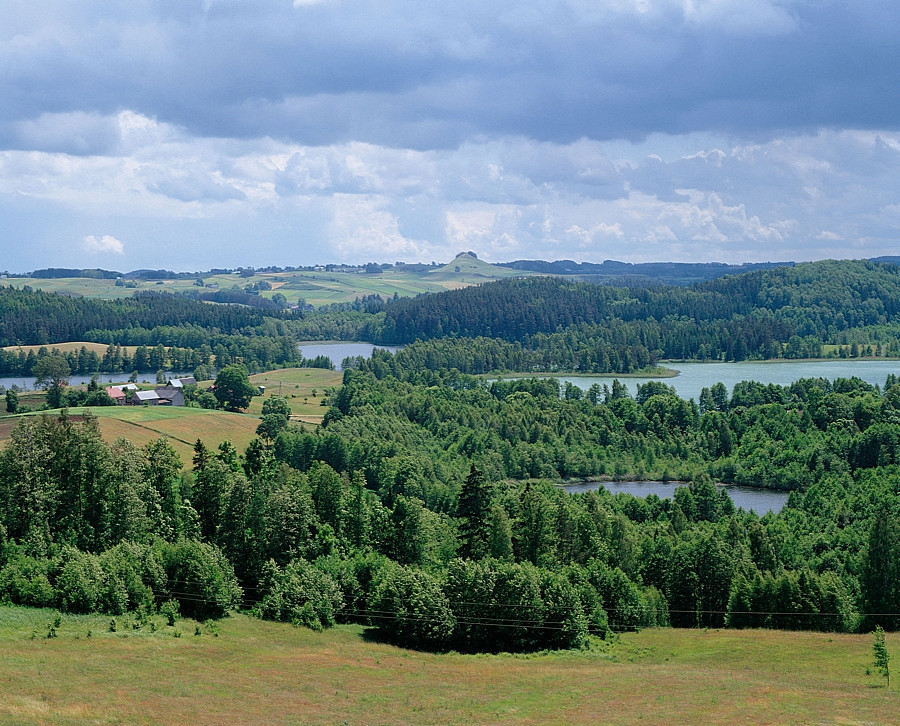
left=0, top=607, right=900, bottom=726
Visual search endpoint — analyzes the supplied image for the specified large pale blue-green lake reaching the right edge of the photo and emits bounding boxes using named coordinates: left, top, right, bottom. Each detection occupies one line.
left=554, top=359, right=900, bottom=401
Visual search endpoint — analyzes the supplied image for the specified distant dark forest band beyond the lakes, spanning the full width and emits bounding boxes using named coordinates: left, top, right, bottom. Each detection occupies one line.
left=7, top=261, right=900, bottom=375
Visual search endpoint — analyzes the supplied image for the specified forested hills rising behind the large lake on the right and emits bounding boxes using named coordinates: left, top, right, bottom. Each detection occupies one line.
left=294, top=260, right=900, bottom=374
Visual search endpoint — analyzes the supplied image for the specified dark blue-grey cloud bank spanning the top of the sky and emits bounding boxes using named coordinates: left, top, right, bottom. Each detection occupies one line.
left=0, top=0, right=900, bottom=153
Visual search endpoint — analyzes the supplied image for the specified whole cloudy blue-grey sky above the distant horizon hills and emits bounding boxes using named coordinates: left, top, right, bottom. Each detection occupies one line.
left=0, top=0, right=900, bottom=272
